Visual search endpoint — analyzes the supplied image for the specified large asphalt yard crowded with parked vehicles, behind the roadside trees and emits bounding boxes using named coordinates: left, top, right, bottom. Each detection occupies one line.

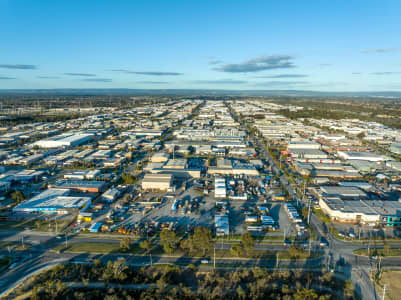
left=69, top=168, right=297, bottom=237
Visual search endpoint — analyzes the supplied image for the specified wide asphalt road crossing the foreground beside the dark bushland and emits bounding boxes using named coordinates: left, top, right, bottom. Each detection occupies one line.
left=0, top=232, right=401, bottom=299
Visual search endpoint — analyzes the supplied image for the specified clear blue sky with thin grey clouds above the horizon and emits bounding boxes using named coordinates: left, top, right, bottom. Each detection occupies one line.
left=0, top=0, right=401, bottom=91
